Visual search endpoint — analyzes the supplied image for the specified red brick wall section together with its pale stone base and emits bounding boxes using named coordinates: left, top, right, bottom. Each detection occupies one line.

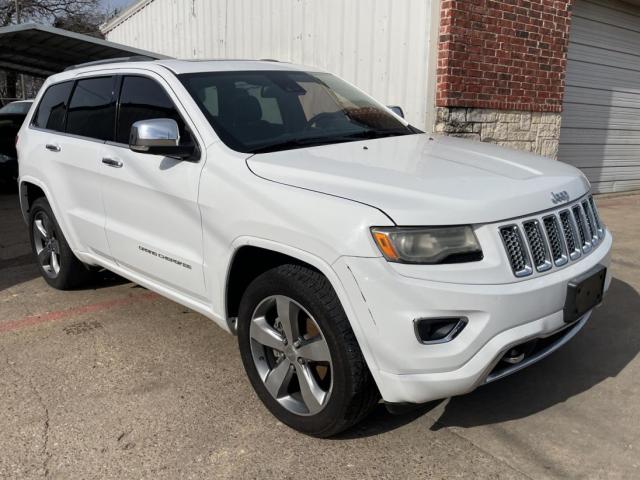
left=435, top=0, right=573, bottom=158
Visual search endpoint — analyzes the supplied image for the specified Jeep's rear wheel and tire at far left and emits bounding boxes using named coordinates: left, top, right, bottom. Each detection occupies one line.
left=29, top=197, right=92, bottom=290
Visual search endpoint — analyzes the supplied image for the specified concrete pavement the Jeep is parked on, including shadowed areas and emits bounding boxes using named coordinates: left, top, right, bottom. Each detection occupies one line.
left=0, top=191, right=640, bottom=479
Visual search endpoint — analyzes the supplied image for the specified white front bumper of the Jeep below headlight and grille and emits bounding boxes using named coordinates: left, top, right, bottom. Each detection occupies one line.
left=334, top=232, right=612, bottom=403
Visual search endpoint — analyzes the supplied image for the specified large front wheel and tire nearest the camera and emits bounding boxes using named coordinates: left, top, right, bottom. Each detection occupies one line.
left=238, top=265, right=379, bottom=437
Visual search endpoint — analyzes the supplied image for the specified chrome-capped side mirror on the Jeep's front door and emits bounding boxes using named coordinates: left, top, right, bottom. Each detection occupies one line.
left=129, top=118, right=195, bottom=158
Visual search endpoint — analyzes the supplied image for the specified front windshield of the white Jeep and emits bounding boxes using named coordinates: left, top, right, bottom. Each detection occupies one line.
left=180, top=71, right=419, bottom=153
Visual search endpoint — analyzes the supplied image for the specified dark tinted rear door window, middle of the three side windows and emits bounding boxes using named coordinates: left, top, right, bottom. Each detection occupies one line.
left=67, top=77, right=116, bottom=140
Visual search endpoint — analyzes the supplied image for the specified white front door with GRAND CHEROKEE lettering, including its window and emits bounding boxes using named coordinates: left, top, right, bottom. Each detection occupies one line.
left=100, top=74, right=206, bottom=300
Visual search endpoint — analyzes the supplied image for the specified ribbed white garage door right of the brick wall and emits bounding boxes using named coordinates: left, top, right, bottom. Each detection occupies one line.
left=558, top=0, right=640, bottom=192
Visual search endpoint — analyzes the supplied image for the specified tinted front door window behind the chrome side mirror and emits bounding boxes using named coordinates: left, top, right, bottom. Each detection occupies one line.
left=116, top=77, right=190, bottom=144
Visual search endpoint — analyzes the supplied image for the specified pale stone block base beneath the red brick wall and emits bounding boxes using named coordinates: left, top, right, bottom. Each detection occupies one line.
left=435, top=107, right=561, bottom=159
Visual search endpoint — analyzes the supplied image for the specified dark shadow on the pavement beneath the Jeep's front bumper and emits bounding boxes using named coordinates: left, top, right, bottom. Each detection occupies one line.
left=338, top=278, right=640, bottom=439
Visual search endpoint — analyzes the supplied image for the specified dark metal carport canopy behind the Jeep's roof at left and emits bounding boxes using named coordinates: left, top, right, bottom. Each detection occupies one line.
left=0, top=23, right=167, bottom=77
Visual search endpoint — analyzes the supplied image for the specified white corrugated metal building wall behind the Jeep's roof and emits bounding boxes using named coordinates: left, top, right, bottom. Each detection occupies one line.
left=107, top=0, right=432, bottom=128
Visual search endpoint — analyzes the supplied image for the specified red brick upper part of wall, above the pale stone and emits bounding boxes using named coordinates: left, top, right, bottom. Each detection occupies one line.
left=436, top=0, right=572, bottom=112
